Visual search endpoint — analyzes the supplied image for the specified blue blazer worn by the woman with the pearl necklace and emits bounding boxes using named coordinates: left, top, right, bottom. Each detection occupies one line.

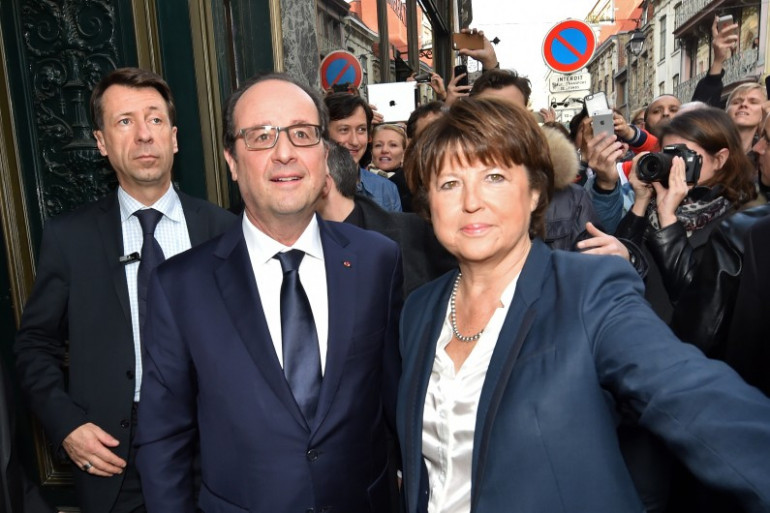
left=397, top=241, right=770, bottom=513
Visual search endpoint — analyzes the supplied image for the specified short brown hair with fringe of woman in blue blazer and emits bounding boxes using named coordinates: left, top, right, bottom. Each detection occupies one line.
left=404, top=97, right=553, bottom=237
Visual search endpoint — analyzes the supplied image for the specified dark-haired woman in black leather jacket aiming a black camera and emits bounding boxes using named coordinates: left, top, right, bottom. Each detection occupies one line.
left=615, top=107, right=756, bottom=324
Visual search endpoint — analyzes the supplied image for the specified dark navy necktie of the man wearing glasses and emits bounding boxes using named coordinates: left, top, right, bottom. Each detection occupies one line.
left=275, top=249, right=321, bottom=425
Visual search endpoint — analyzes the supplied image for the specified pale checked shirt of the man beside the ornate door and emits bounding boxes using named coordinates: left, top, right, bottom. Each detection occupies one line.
left=118, top=185, right=190, bottom=401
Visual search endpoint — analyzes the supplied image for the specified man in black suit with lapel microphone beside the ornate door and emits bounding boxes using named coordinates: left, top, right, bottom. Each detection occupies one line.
left=15, top=68, right=235, bottom=513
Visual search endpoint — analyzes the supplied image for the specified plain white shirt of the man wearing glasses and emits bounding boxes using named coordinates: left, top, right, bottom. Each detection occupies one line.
left=243, top=212, right=329, bottom=375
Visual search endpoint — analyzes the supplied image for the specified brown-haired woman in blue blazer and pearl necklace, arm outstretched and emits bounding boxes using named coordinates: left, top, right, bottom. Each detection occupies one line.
left=397, top=99, right=770, bottom=513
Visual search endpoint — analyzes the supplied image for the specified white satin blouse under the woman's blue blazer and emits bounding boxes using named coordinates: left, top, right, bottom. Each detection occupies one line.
left=422, top=275, right=519, bottom=513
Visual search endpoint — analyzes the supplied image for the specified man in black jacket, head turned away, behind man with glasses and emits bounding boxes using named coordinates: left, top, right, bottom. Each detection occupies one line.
left=318, top=142, right=457, bottom=297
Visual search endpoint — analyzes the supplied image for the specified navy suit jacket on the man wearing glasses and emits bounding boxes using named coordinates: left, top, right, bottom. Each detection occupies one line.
left=136, top=215, right=403, bottom=513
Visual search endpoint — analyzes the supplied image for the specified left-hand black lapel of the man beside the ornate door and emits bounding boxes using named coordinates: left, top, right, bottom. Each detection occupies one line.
left=96, top=192, right=131, bottom=325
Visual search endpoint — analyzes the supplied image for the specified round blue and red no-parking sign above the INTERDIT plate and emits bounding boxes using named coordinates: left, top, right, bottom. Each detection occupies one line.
left=543, top=20, right=596, bottom=73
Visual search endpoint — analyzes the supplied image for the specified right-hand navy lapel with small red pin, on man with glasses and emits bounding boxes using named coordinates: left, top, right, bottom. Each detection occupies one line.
left=312, top=217, right=360, bottom=431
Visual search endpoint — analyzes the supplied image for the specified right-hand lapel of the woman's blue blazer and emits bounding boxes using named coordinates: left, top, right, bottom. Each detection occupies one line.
left=464, top=240, right=551, bottom=510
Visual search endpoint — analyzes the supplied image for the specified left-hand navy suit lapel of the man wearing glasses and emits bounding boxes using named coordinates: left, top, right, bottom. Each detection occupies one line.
left=213, top=220, right=307, bottom=428
